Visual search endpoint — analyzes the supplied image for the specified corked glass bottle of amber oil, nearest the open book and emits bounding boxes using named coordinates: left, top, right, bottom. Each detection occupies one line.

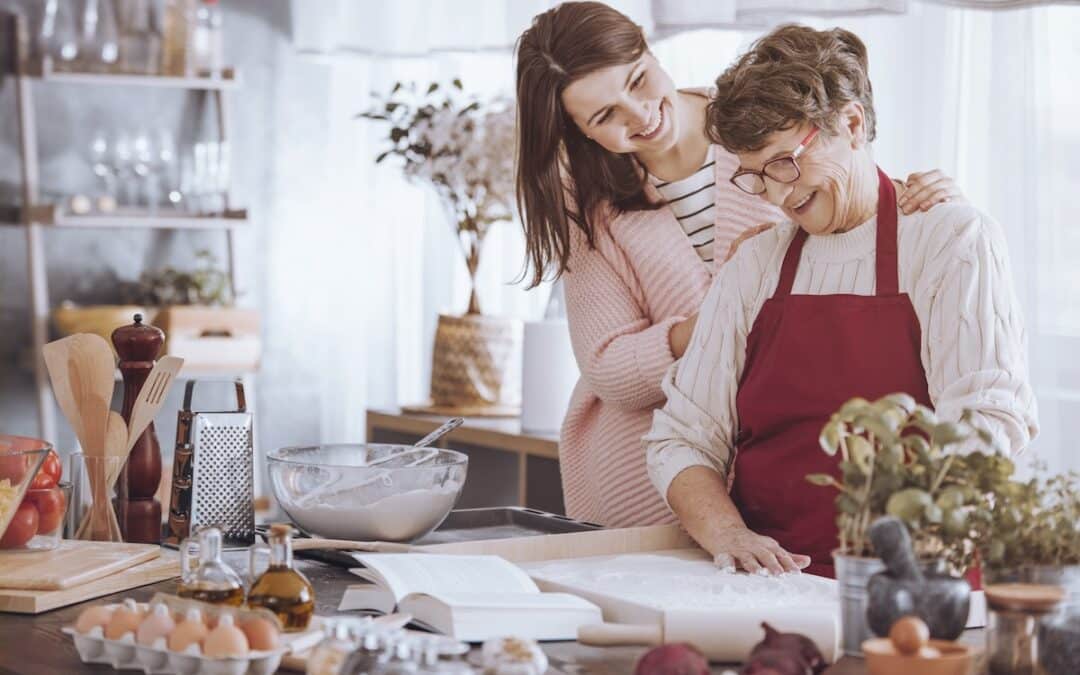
left=247, top=523, right=315, bottom=633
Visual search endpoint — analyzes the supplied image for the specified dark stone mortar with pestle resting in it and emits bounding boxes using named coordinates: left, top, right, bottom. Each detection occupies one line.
left=866, top=516, right=971, bottom=640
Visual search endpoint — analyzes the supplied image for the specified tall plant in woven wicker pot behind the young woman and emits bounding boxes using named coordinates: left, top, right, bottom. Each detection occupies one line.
left=359, top=79, right=522, bottom=415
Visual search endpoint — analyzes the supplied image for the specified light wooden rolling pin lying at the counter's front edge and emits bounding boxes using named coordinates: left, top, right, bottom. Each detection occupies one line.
left=578, top=607, right=840, bottom=663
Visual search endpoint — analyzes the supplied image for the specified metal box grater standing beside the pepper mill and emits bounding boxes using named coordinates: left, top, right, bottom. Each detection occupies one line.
left=165, top=380, right=255, bottom=549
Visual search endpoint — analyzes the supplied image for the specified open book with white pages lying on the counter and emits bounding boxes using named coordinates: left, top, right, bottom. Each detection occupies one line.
left=338, top=553, right=603, bottom=643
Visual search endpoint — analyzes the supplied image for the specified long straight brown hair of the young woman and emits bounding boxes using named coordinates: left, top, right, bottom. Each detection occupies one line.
left=515, top=2, right=660, bottom=287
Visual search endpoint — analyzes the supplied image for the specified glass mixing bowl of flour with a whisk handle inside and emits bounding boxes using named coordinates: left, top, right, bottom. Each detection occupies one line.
left=267, top=443, right=469, bottom=541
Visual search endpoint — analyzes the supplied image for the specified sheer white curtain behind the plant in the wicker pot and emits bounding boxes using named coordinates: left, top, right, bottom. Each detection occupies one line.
left=260, top=38, right=549, bottom=445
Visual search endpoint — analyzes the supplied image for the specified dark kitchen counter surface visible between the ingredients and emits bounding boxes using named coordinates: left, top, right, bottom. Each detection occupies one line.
left=0, top=553, right=983, bottom=675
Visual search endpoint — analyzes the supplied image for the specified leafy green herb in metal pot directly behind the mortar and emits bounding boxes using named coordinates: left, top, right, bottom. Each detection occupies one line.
left=807, top=394, right=1013, bottom=654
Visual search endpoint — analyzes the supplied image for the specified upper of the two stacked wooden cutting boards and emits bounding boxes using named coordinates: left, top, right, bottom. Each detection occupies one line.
left=0, top=539, right=161, bottom=591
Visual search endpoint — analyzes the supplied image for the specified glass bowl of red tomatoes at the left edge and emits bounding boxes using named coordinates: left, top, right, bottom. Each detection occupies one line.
left=0, top=434, right=70, bottom=554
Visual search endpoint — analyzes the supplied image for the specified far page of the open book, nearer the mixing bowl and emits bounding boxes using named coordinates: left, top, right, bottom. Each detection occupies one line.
left=352, top=553, right=540, bottom=600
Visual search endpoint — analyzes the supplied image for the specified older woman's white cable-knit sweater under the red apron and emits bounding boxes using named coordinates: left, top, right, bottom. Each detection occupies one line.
left=644, top=203, right=1037, bottom=499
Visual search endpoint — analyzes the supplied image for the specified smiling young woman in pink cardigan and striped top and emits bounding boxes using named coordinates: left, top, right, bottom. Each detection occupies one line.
left=516, top=2, right=958, bottom=526
